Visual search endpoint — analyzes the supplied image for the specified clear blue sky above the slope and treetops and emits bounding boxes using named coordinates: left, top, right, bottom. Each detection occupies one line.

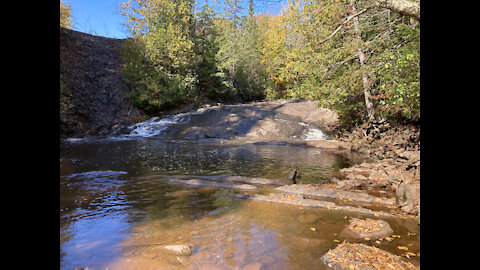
left=64, top=0, right=286, bottom=38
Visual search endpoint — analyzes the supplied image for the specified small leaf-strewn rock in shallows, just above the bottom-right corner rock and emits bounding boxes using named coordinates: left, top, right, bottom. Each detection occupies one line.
left=340, top=218, right=393, bottom=240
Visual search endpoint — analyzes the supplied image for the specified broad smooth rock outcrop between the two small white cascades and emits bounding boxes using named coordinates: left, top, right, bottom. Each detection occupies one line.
left=162, top=100, right=345, bottom=141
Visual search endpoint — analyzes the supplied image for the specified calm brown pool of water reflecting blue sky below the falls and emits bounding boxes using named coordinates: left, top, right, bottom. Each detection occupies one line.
left=60, top=139, right=419, bottom=270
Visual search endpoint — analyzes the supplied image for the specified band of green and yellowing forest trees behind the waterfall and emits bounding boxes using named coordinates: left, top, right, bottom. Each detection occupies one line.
left=61, top=0, right=420, bottom=126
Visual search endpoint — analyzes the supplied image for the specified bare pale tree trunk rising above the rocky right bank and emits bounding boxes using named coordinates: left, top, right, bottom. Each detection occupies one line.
left=350, top=0, right=375, bottom=122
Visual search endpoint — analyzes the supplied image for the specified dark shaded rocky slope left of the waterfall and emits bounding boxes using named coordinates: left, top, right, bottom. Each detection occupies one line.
left=60, top=28, right=144, bottom=137
